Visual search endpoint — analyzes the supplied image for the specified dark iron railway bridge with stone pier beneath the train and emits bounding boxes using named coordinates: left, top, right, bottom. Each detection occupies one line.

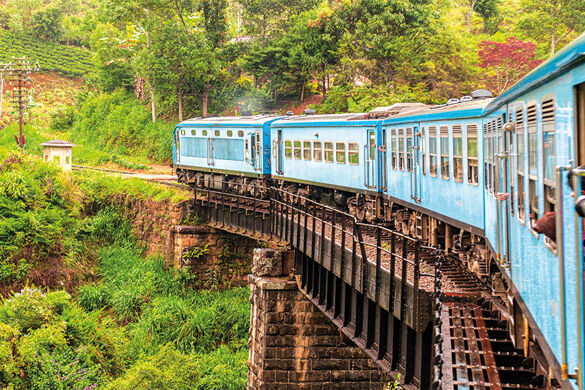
left=188, top=185, right=544, bottom=390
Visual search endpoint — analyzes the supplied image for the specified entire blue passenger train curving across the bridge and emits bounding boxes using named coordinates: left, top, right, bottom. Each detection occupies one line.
left=173, top=35, right=585, bottom=389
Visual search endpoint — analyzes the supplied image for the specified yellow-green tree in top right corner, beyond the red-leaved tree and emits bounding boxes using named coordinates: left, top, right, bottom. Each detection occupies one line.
left=518, top=0, right=585, bottom=55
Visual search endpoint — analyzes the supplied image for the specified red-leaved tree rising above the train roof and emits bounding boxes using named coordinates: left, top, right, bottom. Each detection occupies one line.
left=478, top=37, right=542, bottom=95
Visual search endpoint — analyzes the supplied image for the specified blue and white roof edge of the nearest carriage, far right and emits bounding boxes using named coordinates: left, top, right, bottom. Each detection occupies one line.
left=485, top=33, right=585, bottom=113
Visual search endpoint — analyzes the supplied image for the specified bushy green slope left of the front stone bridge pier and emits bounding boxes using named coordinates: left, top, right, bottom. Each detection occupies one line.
left=0, top=154, right=250, bottom=389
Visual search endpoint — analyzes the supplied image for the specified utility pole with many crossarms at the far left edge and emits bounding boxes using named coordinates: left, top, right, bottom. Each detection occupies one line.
left=0, top=57, right=39, bottom=149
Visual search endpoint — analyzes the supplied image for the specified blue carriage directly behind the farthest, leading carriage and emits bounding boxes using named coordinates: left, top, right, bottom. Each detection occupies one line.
left=271, top=114, right=380, bottom=216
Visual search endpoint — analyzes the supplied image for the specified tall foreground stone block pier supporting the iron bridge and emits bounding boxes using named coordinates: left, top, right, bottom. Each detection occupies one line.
left=248, top=248, right=393, bottom=390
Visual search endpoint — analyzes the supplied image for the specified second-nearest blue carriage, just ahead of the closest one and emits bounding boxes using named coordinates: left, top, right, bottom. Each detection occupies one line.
left=381, top=95, right=491, bottom=276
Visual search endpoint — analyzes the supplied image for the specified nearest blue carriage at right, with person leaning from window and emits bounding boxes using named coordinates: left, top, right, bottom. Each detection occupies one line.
left=483, top=32, right=585, bottom=389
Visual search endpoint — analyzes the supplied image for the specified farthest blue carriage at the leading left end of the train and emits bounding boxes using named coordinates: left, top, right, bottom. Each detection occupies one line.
left=173, top=115, right=279, bottom=195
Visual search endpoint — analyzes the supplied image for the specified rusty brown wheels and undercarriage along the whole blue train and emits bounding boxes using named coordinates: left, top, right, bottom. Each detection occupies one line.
left=177, top=170, right=559, bottom=389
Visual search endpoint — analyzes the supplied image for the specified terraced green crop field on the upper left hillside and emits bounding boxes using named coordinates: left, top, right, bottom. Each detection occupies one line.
left=0, top=31, right=94, bottom=77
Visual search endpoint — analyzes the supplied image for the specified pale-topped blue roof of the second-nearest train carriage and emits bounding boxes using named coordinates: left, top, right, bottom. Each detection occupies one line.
left=382, top=99, right=493, bottom=125
